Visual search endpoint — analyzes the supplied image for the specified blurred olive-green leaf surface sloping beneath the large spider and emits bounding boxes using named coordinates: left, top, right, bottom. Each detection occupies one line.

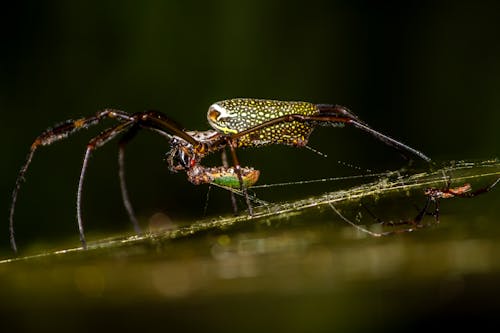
left=0, top=161, right=500, bottom=332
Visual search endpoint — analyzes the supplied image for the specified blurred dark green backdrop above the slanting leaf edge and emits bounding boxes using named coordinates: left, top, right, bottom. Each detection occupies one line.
left=0, top=0, right=500, bottom=249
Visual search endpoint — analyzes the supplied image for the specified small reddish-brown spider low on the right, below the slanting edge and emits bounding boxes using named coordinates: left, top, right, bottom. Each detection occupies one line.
left=336, top=178, right=500, bottom=237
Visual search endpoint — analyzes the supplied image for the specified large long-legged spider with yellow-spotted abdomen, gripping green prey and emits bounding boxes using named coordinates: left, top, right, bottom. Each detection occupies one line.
left=9, top=98, right=431, bottom=251
